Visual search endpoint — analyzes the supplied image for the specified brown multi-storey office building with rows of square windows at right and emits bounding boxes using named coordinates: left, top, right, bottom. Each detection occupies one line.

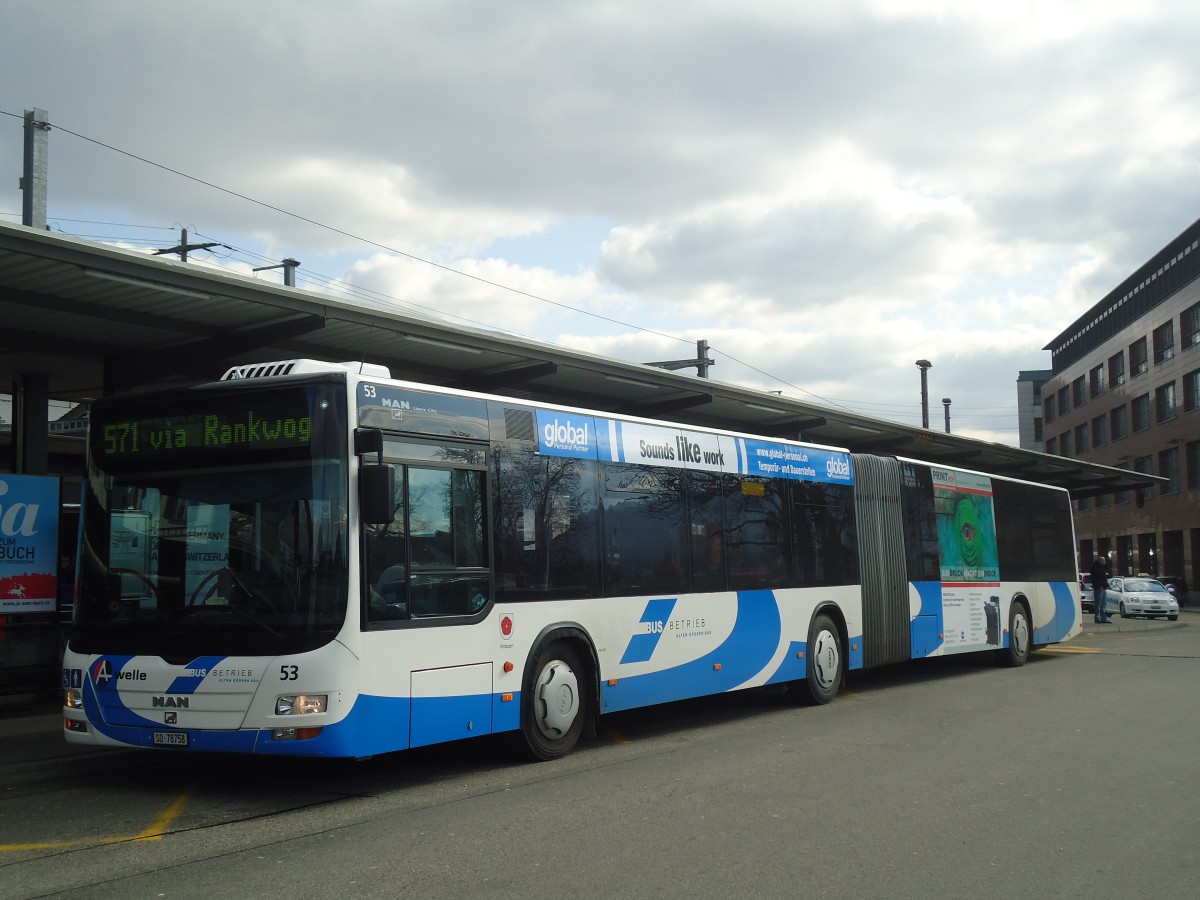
left=1042, top=214, right=1200, bottom=588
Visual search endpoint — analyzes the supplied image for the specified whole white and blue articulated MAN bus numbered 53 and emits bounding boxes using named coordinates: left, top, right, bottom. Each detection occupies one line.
left=62, top=360, right=1080, bottom=760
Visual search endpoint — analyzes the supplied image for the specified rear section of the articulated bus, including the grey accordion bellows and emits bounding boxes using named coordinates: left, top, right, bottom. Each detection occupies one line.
left=854, top=455, right=1081, bottom=667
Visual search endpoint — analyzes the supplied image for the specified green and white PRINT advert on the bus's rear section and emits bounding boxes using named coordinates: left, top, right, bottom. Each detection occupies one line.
left=932, top=468, right=1001, bottom=649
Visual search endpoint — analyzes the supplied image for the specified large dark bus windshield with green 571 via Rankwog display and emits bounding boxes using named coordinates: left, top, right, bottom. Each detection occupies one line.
left=71, top=376, right=348, bottom=661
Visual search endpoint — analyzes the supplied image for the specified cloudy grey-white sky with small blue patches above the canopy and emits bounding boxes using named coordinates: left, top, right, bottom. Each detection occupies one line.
left=0, top=0, right=1200, bottom=444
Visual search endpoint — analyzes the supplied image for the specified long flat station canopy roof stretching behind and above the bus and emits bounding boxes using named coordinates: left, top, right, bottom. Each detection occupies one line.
left=0, top=223, right=1160, bottom=497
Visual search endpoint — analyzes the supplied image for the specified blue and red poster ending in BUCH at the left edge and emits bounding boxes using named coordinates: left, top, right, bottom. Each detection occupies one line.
left=0, top=475, right=59, bottom=614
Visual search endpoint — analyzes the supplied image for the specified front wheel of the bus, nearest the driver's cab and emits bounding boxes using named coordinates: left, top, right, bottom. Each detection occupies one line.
left=521, top=643, right=588, bottom=760
